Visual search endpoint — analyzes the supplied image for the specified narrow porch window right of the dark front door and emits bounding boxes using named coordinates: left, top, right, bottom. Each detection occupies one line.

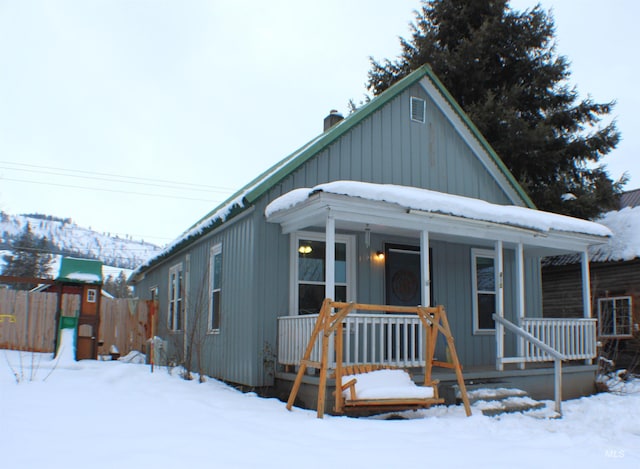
left=471, top=249, right=496, bottom=333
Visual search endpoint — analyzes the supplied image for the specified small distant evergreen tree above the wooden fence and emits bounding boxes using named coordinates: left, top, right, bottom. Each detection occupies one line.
left=2, top=223, right=52, bottom=290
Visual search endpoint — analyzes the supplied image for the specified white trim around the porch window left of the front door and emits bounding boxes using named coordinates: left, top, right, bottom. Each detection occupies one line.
left=289, top=231, right=357, bottom=316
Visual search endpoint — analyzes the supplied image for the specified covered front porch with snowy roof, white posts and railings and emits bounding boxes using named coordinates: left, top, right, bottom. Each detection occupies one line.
left=265, top=181, right=610, bottom=414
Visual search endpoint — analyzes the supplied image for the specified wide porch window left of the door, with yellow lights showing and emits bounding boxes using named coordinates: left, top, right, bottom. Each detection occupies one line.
left=291, top=233, right=355, bottom=314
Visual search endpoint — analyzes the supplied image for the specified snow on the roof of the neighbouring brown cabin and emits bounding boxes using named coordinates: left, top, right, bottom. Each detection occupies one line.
left=589, top=206, right=640, bottom=262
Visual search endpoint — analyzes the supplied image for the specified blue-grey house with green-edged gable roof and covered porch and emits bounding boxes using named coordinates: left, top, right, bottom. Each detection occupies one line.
left=130, top=66, right=610, bottom=410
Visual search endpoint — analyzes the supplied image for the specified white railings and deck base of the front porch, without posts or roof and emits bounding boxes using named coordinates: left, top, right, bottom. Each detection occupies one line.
left=276, top=312, right=597, bottom=412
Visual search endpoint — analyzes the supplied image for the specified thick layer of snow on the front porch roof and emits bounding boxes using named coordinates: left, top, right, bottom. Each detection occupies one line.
left=265, top=181, right=611, bottom=236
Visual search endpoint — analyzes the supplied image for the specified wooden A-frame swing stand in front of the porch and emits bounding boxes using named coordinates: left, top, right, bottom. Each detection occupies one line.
left=287, top=298, right=471, bottom=418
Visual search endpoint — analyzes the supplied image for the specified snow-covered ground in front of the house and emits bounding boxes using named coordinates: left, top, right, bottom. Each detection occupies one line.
left=0, top=350, right=640, bottom=469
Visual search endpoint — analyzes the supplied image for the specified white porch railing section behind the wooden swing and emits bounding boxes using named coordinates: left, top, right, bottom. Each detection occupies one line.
left=278, top=313, right=424, bottom=368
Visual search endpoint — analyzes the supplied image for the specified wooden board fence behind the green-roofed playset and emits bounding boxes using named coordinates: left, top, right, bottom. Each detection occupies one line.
left=0, top=289, right=151, bottom=355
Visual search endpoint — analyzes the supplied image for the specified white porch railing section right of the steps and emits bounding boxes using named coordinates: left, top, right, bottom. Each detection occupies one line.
left=521, top=318, right=596, bottom=362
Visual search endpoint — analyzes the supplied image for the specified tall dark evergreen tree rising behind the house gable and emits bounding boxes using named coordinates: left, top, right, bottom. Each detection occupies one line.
left=367, top=0, right=627, bottom=218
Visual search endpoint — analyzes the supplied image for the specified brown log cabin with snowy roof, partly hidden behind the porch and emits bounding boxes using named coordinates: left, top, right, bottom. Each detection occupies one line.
left=542, top=189, right=640, bottom=371
